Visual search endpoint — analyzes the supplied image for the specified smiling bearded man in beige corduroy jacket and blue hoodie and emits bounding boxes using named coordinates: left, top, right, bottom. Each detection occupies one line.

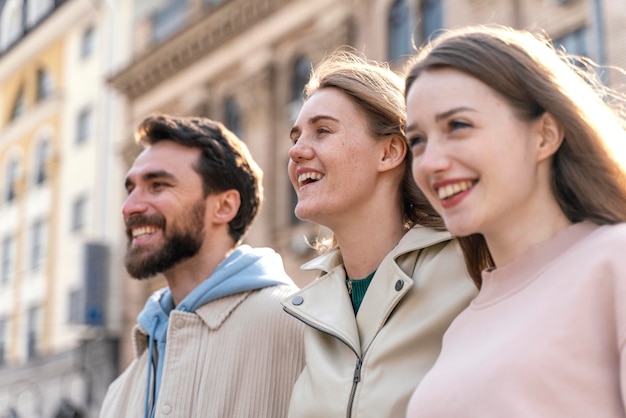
left=100, top=115, right=303, bottom=418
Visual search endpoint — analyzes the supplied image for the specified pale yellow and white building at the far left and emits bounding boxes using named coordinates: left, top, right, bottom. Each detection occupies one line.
left=0, top=0, right=130, bottom=417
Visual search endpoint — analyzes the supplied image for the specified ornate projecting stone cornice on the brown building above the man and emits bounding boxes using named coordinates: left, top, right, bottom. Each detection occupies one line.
left=109, top=0, right=293, bottom=100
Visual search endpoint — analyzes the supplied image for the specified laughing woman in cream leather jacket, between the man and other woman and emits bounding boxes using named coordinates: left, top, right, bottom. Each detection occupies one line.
left=283, top=52, right=476, bottom=418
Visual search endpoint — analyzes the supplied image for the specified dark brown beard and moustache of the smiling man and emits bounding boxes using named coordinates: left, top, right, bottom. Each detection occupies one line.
left=124, top=200, right=206, bottom=279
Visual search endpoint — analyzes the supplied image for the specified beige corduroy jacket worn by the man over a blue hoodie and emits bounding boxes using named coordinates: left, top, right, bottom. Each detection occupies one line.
left=100, top=285, right=304, bottom=418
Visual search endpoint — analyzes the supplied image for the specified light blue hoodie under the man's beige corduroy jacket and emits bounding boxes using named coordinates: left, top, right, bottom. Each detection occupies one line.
left=137, top=245, right=294, bottom=417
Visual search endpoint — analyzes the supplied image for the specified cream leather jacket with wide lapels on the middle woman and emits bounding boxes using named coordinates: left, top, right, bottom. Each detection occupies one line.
left=282, top=227, right=477, bottom=418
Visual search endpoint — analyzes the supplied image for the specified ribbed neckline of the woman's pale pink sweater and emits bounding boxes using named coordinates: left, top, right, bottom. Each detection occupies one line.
left=471, top=221, right=599, bottom=309
